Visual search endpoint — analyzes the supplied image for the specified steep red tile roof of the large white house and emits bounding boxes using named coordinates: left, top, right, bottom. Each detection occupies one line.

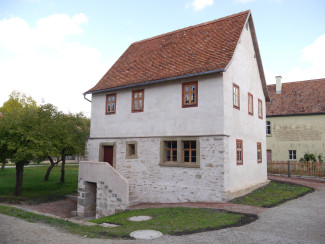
left=85, top=11, right=268, bottom=100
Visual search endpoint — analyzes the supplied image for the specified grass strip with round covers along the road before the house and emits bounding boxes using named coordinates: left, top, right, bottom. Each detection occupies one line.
left=0, top=206, right=257, bottom=239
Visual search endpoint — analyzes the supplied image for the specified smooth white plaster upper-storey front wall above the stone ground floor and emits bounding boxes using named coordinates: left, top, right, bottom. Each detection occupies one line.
left=90, top=74, right=223, bottom=138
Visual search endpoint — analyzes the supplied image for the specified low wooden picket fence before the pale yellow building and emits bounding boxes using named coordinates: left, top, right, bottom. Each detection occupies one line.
left=267, top=161, right=325, bottom=177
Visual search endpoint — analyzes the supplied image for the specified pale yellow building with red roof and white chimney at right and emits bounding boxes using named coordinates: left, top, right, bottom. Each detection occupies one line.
left=266, top=76, right=325, bottom=161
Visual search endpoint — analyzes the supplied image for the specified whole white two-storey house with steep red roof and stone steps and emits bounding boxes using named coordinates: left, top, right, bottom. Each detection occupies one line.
left=78, top=11, right=269, bottom=215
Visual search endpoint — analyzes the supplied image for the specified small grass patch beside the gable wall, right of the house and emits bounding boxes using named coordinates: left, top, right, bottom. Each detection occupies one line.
left=231, top=181, right=314, bottom=208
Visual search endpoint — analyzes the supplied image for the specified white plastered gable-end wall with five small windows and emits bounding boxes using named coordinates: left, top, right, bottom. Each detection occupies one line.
left=223, top=21, right=267, bottom=192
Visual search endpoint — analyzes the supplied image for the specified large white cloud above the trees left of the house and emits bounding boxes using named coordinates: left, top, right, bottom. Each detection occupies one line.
left=0, top=13, right=109, bottom=115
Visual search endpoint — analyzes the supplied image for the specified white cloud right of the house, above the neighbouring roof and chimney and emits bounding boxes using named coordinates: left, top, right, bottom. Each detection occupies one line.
left=265, top=34, right=325, bottom=84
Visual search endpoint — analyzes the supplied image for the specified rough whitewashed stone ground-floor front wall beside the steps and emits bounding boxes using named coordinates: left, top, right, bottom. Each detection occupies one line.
left=87, top=136, right=225, bottom=202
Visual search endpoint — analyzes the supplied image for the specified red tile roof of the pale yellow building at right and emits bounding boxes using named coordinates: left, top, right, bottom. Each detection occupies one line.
left=266, top=79, right=325, bottom=116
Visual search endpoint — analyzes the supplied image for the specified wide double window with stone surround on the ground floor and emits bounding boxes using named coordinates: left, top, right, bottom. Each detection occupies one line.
left=159, top=137, right=200, bottom=168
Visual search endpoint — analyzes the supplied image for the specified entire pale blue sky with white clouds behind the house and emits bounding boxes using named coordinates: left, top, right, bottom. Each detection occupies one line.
left=0, top=0, right=325, bottom=116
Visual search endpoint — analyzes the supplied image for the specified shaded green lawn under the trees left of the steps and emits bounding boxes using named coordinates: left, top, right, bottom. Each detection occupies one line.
left=0, top=165, right=78, bottom=203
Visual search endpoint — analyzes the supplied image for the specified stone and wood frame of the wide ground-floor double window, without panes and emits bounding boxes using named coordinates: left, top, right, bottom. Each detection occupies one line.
left=159, top=137, right=200, bottom=168
